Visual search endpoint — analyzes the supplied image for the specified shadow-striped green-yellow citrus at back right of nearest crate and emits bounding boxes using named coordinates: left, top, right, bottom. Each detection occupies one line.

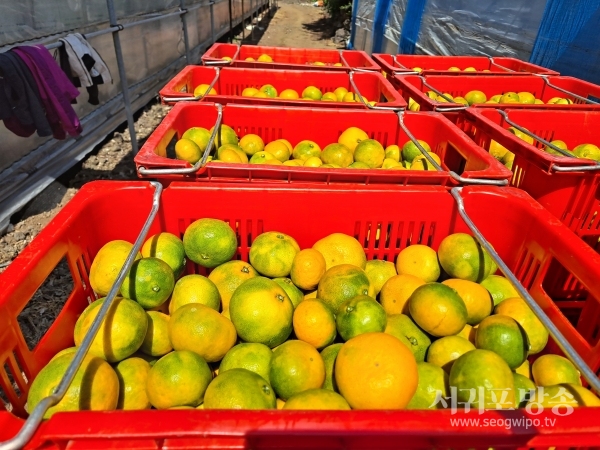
left=438, top=233, right=495, bottom=282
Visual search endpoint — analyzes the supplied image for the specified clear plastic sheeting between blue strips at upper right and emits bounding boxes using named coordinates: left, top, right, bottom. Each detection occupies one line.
left=416, top=0, right=546, bottom=61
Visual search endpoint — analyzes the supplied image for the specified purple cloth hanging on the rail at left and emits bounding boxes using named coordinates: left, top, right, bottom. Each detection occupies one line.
left=13, top=45, right=81, bottom=139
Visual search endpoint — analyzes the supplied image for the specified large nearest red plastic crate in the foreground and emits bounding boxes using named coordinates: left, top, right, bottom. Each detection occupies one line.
left=0, top=181, right=600, bottom=449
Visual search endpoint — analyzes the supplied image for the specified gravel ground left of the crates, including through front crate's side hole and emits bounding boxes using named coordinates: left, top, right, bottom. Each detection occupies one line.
left=0, top=102, right=169, bottom=356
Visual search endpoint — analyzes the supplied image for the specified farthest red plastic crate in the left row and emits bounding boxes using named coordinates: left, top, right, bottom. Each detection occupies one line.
left=202, top=42, right=381, bottom=72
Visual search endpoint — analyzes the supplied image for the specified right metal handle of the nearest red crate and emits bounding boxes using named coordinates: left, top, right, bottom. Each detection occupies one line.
left=450, top=187, right=600, bottom=393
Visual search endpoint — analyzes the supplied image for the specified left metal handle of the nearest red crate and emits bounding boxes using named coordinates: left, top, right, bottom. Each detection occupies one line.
left=0, top=181, right=162, bottom=450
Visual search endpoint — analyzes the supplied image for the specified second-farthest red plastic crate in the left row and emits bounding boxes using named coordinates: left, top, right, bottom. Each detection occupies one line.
left=160, top=66, right=406, bottom=109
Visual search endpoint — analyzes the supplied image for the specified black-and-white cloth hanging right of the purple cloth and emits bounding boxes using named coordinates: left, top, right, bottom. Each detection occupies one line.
left=59, top=33, right=112, bottom=105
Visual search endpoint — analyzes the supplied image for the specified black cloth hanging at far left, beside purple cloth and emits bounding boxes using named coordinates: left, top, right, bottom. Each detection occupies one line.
left=0, top=52, right=52, bottom=137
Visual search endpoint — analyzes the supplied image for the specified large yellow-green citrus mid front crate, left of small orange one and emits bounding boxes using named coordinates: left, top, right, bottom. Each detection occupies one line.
left=229, top=277, right=294, bottom=348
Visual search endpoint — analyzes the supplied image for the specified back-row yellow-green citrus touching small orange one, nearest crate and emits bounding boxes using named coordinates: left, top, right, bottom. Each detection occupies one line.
left=250, top=231, right=300, bottom=278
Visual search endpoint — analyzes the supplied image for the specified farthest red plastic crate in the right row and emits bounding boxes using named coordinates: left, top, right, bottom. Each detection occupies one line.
left=372, top=53, right=560, bottom=75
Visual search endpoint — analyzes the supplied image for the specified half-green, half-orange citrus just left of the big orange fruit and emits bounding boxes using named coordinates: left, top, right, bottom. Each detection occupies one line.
left=269, top=340, right=325, bottom=400
